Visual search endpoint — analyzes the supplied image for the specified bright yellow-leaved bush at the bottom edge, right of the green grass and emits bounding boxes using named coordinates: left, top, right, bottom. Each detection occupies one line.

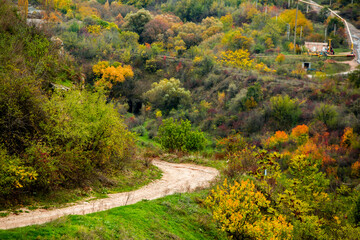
left=204, top=180, right=293, bottom=239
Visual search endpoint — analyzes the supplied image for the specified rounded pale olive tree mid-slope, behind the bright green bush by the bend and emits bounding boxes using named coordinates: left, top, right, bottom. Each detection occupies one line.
left=143, top=78, right=191, bottom=115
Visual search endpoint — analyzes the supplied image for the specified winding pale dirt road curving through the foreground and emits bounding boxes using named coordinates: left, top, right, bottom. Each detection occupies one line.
left=0, top=160, right=219, bottom=229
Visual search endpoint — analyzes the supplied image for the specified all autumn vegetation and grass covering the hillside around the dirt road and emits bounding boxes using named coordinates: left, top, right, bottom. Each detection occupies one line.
left=0, top=0, right=360, bottom=239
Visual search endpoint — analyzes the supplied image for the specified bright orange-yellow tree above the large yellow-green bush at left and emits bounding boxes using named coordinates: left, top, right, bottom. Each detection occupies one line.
left=93, top=61, right=134, bottom=88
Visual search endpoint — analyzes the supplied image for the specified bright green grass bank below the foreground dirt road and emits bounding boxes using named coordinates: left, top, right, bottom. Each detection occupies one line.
left=0, top=191, right=227, bottom=240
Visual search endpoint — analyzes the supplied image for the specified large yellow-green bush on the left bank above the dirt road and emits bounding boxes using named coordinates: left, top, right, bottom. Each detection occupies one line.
left=29, top=90, right=134, bottom=189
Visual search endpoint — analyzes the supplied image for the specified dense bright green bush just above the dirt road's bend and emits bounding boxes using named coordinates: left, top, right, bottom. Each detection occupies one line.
left=157, top=118, right=206, bottom=152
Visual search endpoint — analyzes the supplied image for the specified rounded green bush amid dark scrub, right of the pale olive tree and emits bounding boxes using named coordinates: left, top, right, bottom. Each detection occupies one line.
left=270, top=95, right=301, bottom=129
